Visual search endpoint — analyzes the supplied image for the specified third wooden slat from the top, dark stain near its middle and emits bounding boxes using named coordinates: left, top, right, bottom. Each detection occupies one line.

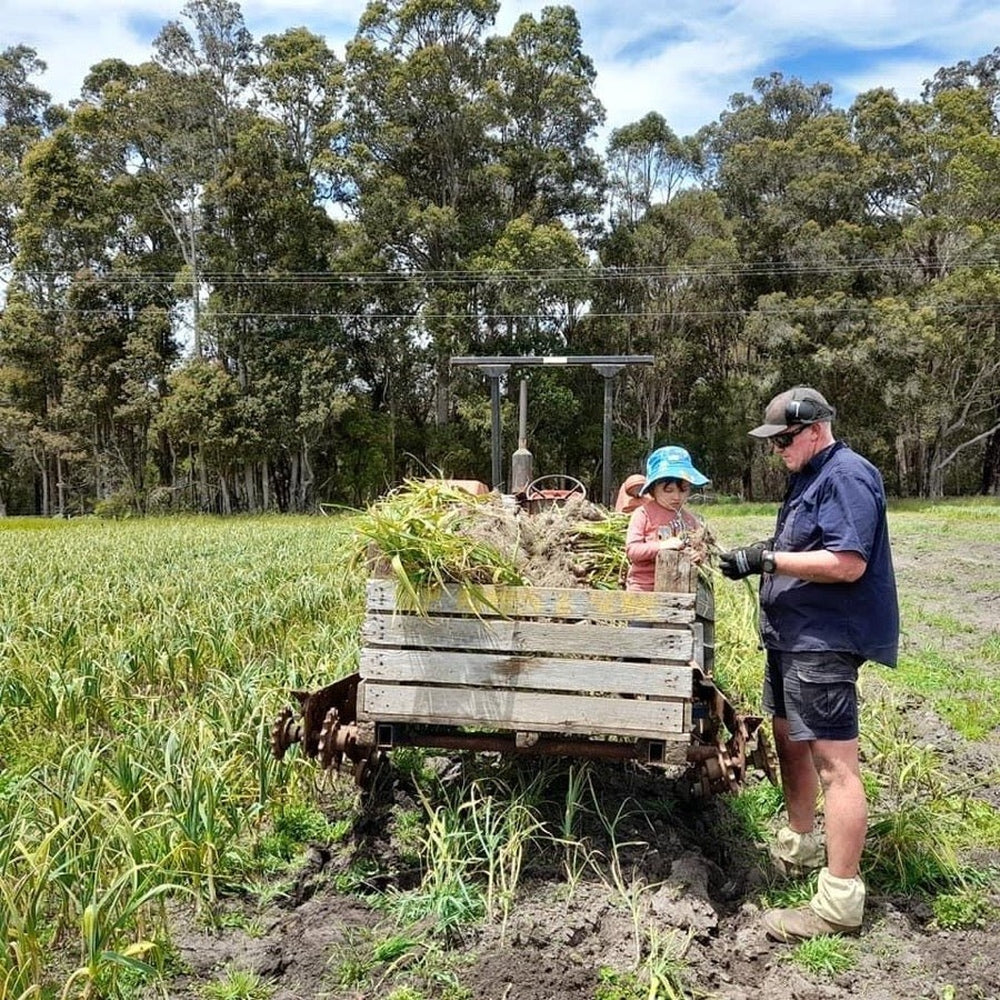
left=361, top=648, right=694, bottom=698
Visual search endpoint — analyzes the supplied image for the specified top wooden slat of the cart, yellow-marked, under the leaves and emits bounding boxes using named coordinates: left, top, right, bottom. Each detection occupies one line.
left=368, top=579, right=696, bottom=625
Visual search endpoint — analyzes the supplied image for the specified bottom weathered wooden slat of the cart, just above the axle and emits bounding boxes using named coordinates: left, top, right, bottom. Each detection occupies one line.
left=358, top=681, right=691, bottom=740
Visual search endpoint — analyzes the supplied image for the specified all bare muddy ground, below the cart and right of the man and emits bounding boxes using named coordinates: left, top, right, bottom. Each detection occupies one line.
left=160, top=508, right=1000, bottom=1000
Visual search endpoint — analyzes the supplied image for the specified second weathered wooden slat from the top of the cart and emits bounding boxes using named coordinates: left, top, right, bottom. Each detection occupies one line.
left=362, top=614, right=694, bottom=663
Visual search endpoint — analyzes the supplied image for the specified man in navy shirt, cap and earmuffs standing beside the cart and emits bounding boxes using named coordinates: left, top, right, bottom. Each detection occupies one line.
left=720, top=386, right=899, bottom=941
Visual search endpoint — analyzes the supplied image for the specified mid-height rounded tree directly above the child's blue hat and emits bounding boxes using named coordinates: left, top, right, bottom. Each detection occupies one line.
left=587, top=188, right=747, bottom=484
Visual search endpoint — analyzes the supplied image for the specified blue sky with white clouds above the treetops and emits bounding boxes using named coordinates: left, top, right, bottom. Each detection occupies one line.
left=0, top=0, right=1000, bottom=147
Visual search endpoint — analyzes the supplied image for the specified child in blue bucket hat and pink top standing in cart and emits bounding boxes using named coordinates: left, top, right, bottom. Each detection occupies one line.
left=625, top=444, right=709, bottom=590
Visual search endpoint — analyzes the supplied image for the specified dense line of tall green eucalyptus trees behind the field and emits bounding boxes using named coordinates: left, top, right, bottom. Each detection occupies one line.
left=0, top=0, right=1000, bottom=514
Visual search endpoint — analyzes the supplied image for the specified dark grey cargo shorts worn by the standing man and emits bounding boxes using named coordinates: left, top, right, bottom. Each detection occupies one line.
left=763, top=650, right=864, bottom=741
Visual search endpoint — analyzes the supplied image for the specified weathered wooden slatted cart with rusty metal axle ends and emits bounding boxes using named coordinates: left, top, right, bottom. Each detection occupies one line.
left=272, top=553, right=766, bottom=794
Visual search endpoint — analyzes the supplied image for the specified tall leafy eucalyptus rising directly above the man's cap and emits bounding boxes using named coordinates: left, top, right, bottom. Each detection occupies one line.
left=701, top=73, right=892, bottom=494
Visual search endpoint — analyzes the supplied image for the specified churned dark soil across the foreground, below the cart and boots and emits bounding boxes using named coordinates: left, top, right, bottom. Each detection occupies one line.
left=162, top=760, right=1000, bottom=1000
